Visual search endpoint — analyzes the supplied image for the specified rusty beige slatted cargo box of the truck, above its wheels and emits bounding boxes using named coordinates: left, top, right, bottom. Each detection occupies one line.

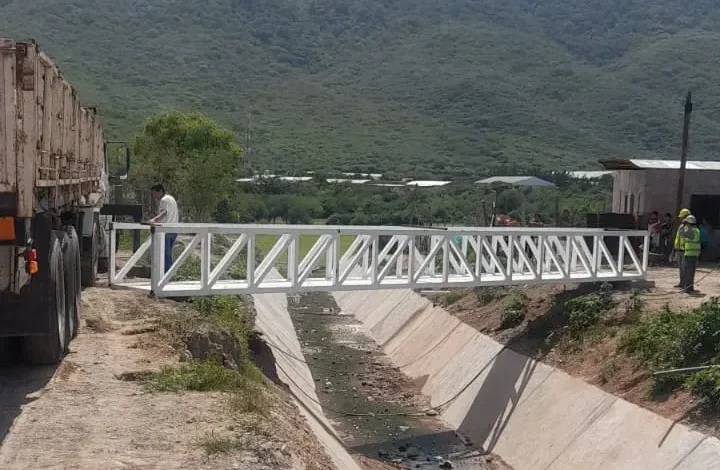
left=0, top=39, right=104, bottom=218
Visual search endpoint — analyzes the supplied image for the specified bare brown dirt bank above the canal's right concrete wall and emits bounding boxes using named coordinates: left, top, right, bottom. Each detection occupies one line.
left=437, top=265, right=720, bottom=437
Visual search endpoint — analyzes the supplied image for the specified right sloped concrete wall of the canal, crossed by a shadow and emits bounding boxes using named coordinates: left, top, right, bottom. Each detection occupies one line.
left=334, top=290, right=720, bottom=470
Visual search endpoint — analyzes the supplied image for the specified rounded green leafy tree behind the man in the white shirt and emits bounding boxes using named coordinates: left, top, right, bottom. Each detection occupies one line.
left=132, top=112, right=243, bottom=221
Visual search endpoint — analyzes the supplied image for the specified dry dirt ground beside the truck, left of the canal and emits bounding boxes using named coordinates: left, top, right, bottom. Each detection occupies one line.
left=0, top=282, right=334, bottom=470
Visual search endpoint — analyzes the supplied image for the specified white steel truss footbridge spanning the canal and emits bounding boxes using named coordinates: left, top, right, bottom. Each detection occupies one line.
left=109, top=223, right=649, bottom=297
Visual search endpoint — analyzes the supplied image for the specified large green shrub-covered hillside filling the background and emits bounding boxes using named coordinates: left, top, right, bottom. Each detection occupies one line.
left=0, top=0, right=720, bottom=177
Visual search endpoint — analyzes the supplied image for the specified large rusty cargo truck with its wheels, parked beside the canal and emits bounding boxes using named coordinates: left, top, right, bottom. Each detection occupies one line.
left=0, top=38, right=134, bottom=364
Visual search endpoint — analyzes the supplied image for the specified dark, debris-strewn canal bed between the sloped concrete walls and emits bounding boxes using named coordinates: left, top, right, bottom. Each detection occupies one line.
left=288, top=293, right=509, bottom=470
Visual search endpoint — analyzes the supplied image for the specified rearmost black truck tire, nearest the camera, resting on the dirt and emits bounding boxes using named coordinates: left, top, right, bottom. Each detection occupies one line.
left=23, top=238, right=69, bottom=365
